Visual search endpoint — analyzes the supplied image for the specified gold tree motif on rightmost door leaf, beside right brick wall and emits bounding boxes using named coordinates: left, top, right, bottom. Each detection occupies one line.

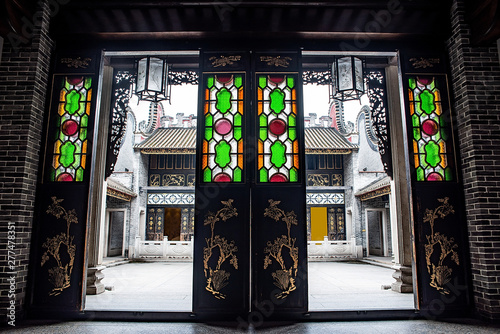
left=423, top=197, right=460, bottom=295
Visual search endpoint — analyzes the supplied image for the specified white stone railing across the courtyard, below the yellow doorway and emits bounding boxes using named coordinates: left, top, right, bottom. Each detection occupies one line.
left=307, top=237, right=363, bottom=261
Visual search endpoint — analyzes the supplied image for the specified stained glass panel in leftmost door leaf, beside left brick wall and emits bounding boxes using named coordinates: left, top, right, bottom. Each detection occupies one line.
left=50, top=76, right=92, bottom=182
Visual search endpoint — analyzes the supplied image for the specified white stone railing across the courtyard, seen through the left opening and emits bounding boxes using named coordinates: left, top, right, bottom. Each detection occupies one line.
left=135, top=238, right=193, bottom=260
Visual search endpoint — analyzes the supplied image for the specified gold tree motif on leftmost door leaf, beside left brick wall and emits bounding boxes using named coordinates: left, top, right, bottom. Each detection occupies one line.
left=41, top=196, right=78, bottom=296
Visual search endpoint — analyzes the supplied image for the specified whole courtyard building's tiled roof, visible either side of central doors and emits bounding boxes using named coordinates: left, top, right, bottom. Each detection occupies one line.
left=135, top=127, right=358, bottom=154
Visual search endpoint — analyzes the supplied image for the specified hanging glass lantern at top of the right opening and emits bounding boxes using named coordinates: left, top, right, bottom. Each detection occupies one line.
left=330, top=56, right=365, bottom=101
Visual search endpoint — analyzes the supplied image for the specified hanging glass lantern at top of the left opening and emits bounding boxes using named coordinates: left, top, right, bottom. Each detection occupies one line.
left=135, top=57, right=170, bottom=103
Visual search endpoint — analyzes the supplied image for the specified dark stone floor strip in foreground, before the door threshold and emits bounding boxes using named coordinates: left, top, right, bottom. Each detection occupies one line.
left=2, top=319, right=500, bottom=334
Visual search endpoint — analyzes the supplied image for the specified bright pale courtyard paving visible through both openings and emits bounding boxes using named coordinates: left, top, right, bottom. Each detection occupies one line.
left=85, top=262, right=414, bottom=311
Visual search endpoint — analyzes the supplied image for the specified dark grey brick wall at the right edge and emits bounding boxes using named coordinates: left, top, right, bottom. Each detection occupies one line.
left=448, top=0, right=500, bottom=319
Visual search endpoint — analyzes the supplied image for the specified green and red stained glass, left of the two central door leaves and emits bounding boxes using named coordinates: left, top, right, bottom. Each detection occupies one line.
left=202, top=74, right=244, bottom=182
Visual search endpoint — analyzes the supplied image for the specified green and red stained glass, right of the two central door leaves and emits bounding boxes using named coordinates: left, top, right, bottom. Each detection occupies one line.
left=257, top=74, right=299, bottom=182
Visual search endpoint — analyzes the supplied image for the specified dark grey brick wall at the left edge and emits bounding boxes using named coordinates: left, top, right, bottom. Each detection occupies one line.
left=0, top=1, right=53, bottom=323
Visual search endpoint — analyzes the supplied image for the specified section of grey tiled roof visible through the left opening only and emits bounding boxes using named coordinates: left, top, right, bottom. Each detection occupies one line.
left=135, top=128, right=196, bottom=154
